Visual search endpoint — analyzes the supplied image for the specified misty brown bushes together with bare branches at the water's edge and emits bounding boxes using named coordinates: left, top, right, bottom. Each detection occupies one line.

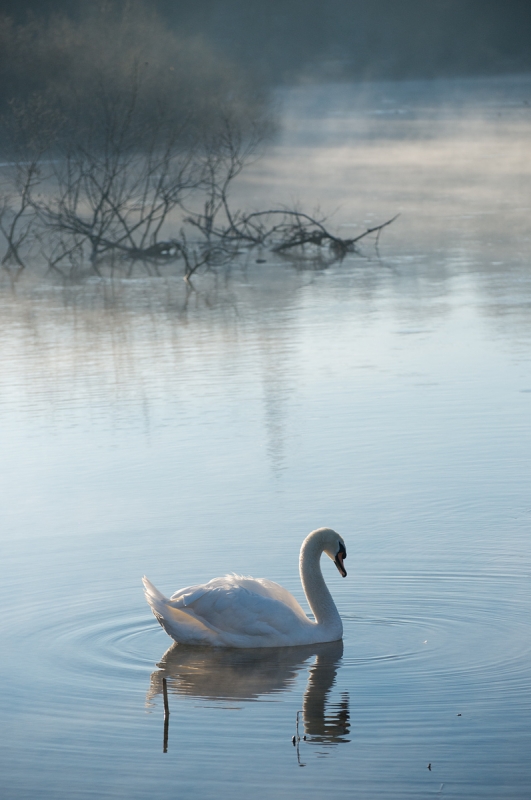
left=0, top=3, right=394, bottom=282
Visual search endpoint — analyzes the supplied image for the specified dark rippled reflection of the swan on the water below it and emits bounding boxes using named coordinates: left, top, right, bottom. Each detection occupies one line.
left=147, top=640, right=350, bottom=752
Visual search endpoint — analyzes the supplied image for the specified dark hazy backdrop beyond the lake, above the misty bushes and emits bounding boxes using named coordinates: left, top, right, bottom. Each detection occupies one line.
left=0, top=0, right=531, bottom=82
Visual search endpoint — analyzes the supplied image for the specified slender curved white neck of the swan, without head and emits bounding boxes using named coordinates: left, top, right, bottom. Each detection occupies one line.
left=299, top=535, right=343, bottom=638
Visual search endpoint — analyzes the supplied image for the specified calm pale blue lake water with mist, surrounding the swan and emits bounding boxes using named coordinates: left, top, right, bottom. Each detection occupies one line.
left=0, top=78, right=531, bottom=800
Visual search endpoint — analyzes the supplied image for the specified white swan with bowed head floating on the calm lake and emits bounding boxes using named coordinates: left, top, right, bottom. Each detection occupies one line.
left=142, top=528, right=347, bottom=647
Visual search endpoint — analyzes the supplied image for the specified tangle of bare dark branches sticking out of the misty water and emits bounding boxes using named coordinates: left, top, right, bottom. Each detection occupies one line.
left=0, top=112, right=396, bottom=280
